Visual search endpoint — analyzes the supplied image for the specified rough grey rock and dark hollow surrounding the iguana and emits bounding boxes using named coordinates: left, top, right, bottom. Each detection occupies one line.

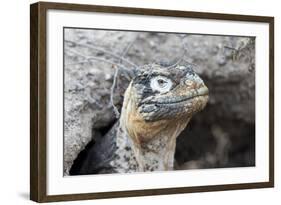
left=64, top=29, right=255, bottom=175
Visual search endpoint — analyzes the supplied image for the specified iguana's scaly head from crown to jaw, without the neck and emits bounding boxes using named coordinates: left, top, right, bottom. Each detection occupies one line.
left=131, top=64, right=209, bottom=122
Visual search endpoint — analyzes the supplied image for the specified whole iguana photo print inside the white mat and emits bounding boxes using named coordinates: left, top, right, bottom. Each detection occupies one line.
left=63, top=28, right=255, bottom=176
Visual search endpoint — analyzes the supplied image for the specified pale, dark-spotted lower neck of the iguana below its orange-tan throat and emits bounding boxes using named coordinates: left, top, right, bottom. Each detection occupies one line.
left=111, top=119, right=187, bottom=173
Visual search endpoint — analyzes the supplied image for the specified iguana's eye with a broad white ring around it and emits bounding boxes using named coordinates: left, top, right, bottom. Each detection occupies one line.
left=150, top=76, right=173, bottom=93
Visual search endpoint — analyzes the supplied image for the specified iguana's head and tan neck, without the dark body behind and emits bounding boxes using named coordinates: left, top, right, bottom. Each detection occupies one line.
left=120, top=64, right=209, bottom=171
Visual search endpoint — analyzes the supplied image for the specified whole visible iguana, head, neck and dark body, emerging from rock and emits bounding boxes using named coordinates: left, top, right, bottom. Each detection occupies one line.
left=70, top=64, right=209, bottom=175
